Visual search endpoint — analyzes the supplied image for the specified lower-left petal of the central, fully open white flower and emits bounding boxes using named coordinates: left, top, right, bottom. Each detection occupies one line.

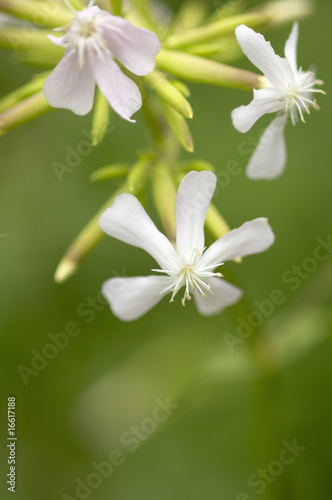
left=102, top=276, right=171, bottom=321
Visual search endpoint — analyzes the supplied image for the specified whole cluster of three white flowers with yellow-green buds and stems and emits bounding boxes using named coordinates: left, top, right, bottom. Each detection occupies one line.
left=0, top=0, right=324, bottom=321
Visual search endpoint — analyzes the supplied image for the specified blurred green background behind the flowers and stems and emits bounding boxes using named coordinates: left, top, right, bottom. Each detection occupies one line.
left=0, top=0, right=332, bottom=500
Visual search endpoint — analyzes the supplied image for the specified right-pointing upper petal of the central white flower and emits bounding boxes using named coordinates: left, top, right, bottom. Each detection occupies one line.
left=200, top=217, right=274, bottom=268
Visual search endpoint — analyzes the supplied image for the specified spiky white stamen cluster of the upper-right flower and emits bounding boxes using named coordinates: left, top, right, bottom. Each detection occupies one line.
left=280, top=70, right=325, bottom=125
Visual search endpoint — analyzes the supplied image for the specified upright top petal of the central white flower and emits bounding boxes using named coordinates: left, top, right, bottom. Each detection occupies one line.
left=175, top=170, right=217, bottom=263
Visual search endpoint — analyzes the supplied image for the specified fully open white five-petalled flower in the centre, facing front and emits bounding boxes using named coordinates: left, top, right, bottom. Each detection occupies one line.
left=99, top=170, right=274, bottom=321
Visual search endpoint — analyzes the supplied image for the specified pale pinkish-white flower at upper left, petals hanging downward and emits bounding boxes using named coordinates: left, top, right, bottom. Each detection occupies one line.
left=43, top=6, right=160, bottom=121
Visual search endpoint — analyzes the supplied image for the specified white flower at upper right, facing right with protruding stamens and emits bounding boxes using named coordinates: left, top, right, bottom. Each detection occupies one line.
left=232, top=23, right=325, bottom=179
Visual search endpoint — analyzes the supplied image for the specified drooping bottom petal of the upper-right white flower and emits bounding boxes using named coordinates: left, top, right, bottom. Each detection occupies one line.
left=247, top=114, right=287, bottom=179
